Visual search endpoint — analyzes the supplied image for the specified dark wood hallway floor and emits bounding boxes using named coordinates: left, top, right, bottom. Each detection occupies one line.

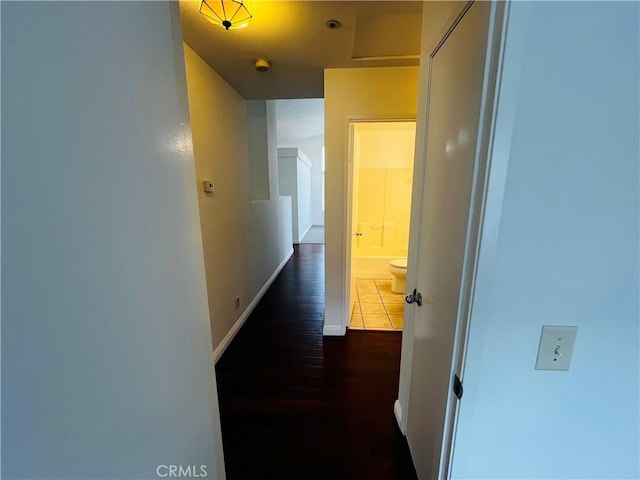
left=216, top=245, right=416, bottom=480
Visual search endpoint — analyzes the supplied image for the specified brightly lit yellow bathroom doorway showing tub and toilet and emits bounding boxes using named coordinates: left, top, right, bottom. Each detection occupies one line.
left=346, top=120, right=416, bottom=330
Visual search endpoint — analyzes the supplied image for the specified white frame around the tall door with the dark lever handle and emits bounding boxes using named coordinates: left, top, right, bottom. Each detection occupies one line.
left=394, top=0, right=509, bottom=480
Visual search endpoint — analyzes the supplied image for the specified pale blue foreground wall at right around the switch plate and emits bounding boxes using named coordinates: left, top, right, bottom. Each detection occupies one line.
left=452, top=2, right=640, bottom=479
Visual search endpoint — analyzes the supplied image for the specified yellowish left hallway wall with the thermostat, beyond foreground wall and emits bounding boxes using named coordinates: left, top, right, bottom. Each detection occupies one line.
left=184, top=49, right=292, bottom=358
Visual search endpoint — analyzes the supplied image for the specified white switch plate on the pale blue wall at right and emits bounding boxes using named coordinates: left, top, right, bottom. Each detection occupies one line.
left=536, top=325, right=578, bottom=370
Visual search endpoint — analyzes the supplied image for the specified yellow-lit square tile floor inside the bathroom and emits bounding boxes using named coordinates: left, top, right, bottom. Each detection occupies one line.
left=349, top=278, right=404, bottom=330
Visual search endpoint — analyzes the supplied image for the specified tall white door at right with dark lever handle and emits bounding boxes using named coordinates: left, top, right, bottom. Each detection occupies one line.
left=407, top=2, right=496, bottom=480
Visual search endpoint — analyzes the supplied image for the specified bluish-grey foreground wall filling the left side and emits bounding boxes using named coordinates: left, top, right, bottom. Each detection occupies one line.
left=2, top=2, right=224, bottom=479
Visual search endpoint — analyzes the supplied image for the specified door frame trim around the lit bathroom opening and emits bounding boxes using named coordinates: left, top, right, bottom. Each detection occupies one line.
left=341, top=114, right=418, bottom=331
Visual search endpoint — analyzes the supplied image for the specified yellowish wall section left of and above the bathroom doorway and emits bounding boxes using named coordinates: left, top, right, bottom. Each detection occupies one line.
left=324, top=67, right=419, bottom=335
